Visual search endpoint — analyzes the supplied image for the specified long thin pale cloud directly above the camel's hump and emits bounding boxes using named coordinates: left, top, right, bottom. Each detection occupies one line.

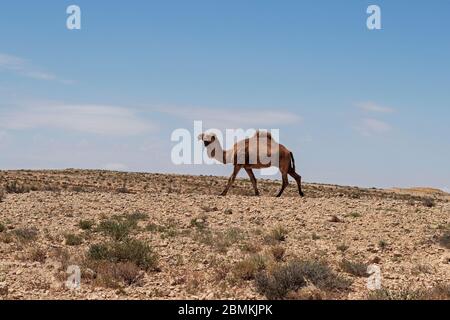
left=160, top=107, right=301, bottom=129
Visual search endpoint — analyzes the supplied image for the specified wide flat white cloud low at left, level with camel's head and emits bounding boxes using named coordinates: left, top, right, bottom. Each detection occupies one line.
left=0, top=104, right=155, bottom=136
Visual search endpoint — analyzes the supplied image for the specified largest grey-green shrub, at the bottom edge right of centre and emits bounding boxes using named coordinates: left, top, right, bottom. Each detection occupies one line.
left=256, top=260, right=351, bottom=299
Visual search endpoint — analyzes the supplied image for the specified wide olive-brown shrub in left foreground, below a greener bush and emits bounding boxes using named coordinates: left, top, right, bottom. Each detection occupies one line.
left=87, top=239, right=158, bottom=270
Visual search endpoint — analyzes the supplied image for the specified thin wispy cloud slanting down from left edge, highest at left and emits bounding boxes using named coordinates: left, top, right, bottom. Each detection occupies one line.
left=0, top=53, right=70, bottom=83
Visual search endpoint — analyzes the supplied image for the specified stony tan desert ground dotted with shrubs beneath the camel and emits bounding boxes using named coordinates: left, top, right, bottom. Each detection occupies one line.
left=0, top=170, right=450, bottom=299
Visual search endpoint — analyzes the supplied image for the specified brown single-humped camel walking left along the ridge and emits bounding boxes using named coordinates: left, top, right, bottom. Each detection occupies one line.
left=198, top=131, right=304, bottom=197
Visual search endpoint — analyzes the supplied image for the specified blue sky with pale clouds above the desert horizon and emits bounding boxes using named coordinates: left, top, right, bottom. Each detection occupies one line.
left=0, top=0, right=450, bottom=190
